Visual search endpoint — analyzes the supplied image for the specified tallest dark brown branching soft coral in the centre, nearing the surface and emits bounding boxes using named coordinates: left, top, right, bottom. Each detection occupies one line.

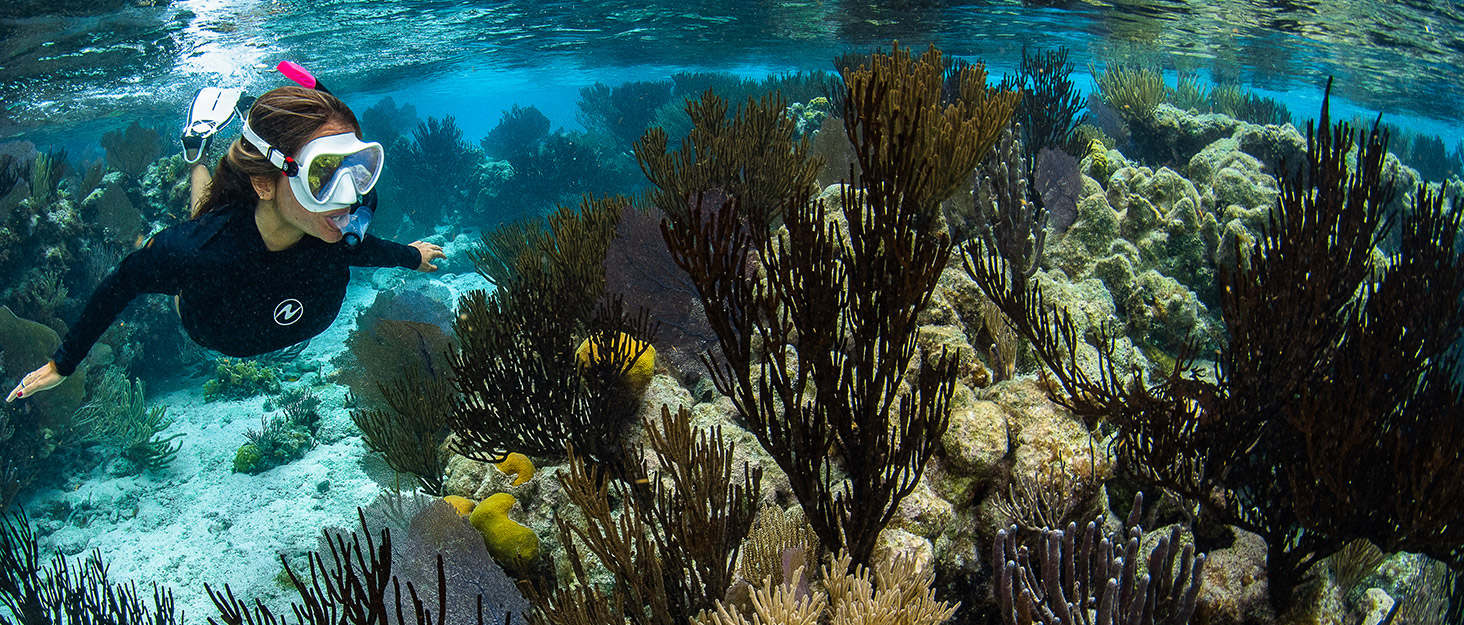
left=647, top=48, right=1017, bottom=573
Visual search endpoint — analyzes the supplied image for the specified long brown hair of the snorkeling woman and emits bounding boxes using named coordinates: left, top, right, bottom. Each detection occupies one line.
left=193, top=86, right=360, bottom=218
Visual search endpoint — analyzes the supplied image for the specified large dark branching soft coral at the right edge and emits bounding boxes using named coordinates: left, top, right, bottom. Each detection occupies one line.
left=968, top=78, right=1464, bottom=606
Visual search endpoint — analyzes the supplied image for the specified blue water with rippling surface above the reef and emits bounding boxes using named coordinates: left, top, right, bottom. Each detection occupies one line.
left=0, top=0, right=1464, bottom=145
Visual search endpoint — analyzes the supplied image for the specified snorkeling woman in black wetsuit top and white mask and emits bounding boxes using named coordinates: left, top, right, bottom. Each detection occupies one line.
left=6, top=86, right=444, bottom=401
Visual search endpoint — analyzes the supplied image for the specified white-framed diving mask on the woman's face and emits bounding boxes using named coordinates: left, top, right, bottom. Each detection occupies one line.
left=243, top=121, right=386, bottom=212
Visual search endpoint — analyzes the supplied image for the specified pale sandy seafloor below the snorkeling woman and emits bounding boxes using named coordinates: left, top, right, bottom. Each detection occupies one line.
left=20, top=247, right=488, bottom=624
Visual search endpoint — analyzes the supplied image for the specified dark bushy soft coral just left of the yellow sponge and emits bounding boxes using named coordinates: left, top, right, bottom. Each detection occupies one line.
left=448, top=198, right=656, bottom=473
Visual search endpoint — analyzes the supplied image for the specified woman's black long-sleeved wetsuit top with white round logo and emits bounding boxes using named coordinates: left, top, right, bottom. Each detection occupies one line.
left=53, top=206, right=422, bottom=375
